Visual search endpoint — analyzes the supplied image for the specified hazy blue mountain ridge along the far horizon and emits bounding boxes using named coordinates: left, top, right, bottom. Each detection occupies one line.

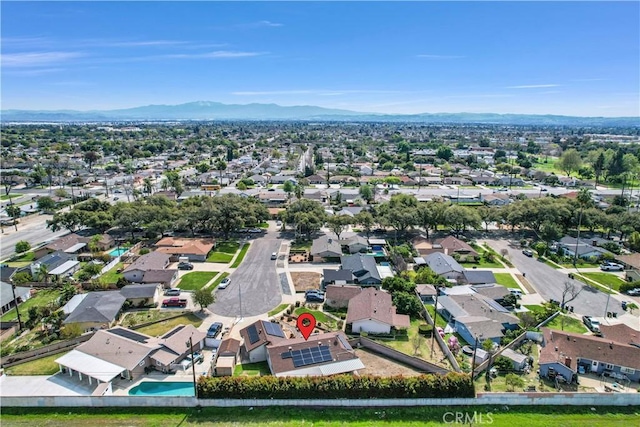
left=0, top=101, right=640, bottom=127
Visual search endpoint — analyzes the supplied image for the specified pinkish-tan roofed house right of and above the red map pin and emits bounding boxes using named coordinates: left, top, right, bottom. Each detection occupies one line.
left=346, top=288, right=410, bottom=334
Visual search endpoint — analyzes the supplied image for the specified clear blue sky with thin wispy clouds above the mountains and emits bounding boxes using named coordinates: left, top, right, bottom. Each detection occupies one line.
left=1, top=1, right=640, bottom=116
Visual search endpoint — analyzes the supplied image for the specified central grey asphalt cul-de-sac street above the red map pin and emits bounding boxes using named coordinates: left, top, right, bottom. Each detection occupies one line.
left=208, top=231, right=282, bottom=317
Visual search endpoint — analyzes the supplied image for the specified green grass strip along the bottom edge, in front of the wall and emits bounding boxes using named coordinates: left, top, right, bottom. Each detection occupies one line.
left=2, top=405, right=640, bottom=427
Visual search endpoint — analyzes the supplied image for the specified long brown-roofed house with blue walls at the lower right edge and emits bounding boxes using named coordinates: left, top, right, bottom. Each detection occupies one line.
left=538, top=328, right=640, bottom=382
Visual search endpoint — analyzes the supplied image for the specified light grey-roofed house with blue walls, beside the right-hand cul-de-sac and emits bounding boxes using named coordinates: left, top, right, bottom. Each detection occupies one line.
left=438, top=293, right=520, bottom=345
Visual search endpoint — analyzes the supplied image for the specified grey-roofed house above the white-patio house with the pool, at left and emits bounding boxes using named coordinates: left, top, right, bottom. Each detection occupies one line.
left=63, top=291, right=126, bottom=332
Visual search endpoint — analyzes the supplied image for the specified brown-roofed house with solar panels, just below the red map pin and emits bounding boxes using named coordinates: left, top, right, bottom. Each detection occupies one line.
left=266, top=331, right=365, bottom=377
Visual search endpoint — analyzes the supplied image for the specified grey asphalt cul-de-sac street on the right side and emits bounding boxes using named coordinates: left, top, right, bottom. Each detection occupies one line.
left=485, top=239, right=624, bottom=317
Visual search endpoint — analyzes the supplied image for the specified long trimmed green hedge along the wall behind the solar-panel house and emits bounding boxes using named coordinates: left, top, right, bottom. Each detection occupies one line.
left=198, top=373, right=475, bottom=399
